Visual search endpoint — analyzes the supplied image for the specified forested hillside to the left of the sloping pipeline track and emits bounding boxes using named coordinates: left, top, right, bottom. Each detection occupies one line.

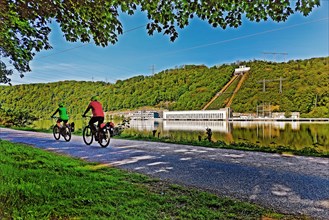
left=0, top=65, right=235, bottom=118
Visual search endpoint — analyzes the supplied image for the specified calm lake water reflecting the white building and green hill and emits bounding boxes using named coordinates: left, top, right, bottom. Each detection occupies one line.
left=34, top=120, right=329, bottom=152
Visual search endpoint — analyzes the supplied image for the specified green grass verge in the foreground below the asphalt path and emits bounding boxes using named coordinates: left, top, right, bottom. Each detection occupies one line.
left=0, top=139, right=306, bottom=219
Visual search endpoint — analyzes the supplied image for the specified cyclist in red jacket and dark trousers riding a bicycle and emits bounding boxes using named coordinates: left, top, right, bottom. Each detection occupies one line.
left=82, top=96, right=104, bottom=137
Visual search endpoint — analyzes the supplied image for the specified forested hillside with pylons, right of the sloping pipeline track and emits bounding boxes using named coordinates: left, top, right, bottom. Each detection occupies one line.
left=231, top=57, right=329, bottom=118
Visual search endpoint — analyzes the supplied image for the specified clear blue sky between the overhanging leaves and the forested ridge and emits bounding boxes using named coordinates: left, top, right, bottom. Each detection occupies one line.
left=5, top=0, right=329, bottom=85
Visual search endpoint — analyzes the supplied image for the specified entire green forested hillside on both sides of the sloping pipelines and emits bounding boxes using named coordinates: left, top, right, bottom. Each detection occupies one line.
left=0, top=57, right=329, bottom=122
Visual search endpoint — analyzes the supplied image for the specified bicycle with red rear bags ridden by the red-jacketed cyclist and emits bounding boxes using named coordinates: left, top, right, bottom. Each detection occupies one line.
left=82, top=116, right=113, bottom=147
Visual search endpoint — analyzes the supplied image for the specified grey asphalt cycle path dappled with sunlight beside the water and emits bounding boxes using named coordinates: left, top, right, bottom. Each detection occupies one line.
left=0, top=128, right=329, bottom=219
